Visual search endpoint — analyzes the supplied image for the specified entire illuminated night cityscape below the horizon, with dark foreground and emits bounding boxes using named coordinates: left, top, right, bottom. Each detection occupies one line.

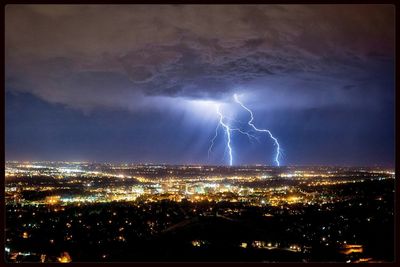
left=5, top=162, right=395, bottom=262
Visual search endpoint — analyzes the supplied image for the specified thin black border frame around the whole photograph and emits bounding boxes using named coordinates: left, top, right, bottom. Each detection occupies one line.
left=0, top=0, right=400, bottom=266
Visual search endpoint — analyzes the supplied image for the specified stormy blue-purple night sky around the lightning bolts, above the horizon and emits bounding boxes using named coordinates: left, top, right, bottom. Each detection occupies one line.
left=5, top=5, right=395, bottom=166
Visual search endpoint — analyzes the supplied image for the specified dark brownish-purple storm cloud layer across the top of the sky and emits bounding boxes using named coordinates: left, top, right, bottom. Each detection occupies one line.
left=6, top=5, right=394, bottom=110
